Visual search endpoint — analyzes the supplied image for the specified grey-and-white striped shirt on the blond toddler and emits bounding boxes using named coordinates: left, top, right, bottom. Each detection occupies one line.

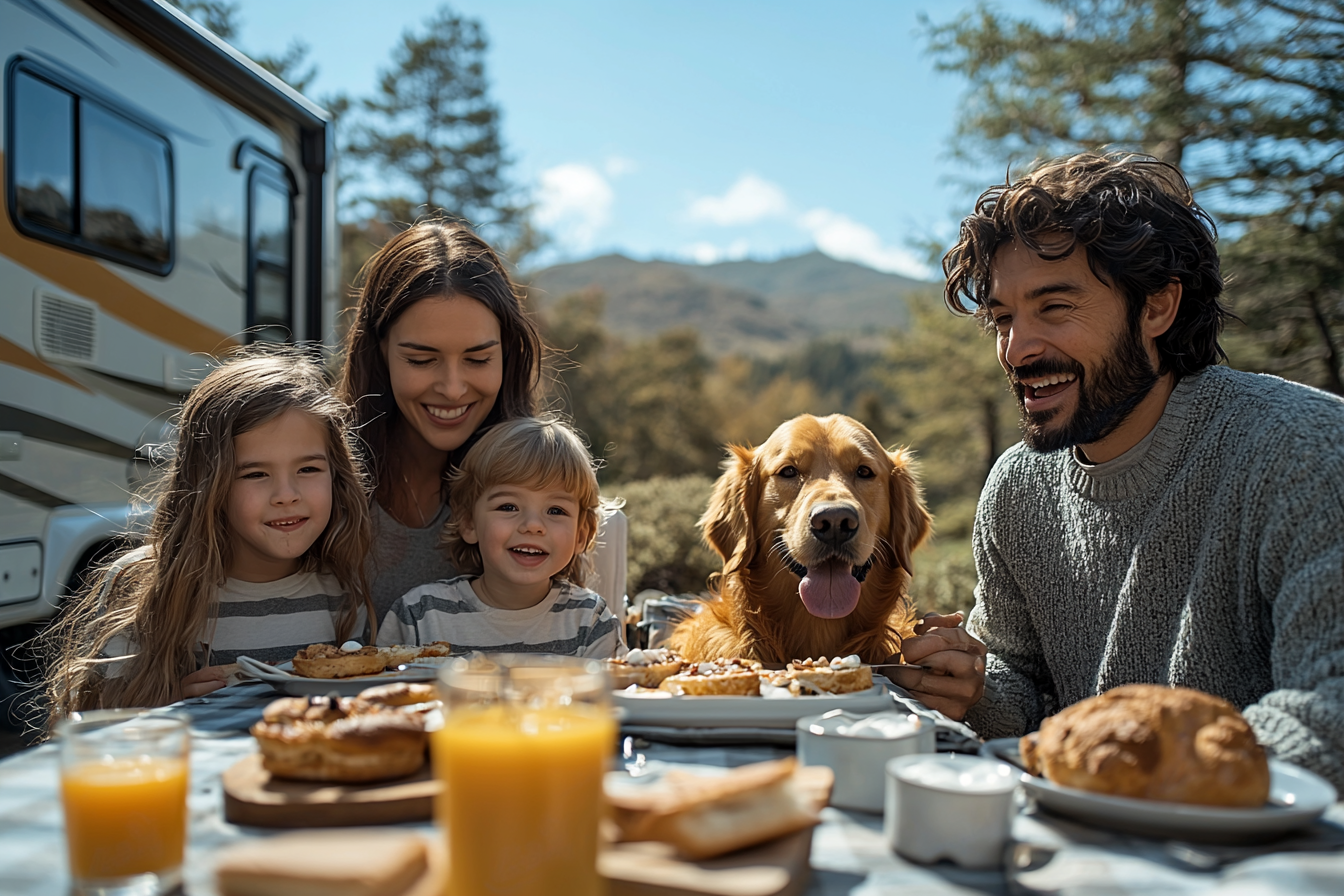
left=378, top=575, right=622, bottom=657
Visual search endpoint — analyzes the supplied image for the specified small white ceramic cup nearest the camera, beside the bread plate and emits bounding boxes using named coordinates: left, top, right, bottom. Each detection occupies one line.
left=883, top=754, right=1021, bottom=868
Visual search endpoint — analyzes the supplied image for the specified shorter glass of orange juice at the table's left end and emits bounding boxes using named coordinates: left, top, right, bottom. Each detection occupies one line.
left=56, top=709, right=191, bottom=896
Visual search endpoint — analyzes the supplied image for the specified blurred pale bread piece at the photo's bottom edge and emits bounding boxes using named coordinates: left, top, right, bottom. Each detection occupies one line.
left=215, top=827, right=427, bottom=896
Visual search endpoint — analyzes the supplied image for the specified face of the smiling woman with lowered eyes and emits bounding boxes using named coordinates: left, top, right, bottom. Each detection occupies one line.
left=382, top=296, right=504, bottom=453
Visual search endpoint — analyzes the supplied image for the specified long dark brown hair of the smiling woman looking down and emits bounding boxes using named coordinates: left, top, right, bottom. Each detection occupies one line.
left=339, top=220, right=543, bottom=501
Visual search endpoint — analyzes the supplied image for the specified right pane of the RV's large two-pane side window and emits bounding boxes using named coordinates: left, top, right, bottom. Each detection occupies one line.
left=79, top=101, right=171, bottom=266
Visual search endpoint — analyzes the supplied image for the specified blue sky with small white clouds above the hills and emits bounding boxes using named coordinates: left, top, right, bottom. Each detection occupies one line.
left=238, top=0, right=1035, bottom=277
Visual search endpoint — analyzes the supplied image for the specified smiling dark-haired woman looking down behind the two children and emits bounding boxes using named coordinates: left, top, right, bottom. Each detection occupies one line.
left=340, top=220, right=543, bottom=618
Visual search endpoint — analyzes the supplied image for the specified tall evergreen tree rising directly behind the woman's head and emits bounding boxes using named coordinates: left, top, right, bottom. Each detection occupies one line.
left=347, top=7, right=524, bottom=247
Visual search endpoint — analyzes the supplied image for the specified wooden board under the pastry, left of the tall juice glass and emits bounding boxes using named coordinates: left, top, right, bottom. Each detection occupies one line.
left=222, top=754, right=439, bottom=827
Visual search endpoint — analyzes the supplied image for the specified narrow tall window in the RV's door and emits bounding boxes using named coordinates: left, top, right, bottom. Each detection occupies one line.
left=249, top=168, right=294, bottom=343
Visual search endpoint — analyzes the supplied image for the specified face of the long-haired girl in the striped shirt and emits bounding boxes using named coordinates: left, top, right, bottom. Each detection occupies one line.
left=224, top=410, right=332, bottom=582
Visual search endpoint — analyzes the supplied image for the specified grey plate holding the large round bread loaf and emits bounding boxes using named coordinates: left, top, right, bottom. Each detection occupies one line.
left=980, top=737, right=1336, bottom=842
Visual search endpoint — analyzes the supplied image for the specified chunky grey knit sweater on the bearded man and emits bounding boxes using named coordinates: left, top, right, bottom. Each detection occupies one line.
left=966, top=367, right=1344, bottom=787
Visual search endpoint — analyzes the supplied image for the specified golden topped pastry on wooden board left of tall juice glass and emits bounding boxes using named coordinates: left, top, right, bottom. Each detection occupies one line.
left=251, top=697, right=427, bottom=783
